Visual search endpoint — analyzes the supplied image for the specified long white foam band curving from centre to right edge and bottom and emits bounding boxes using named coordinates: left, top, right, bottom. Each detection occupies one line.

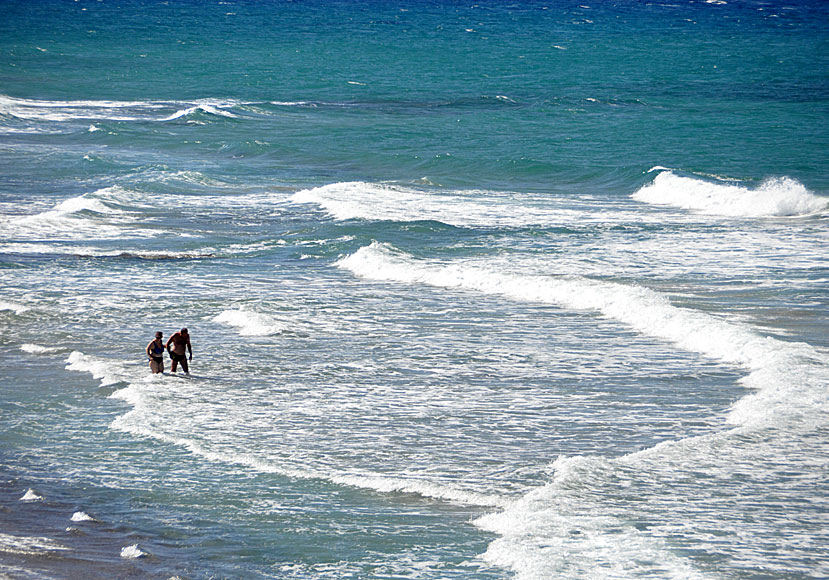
left=338, top=242, right=829, bottom=580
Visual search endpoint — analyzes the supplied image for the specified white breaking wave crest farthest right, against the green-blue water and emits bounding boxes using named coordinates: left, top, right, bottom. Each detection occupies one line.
left=633, top=172, right=829, bottom=217
